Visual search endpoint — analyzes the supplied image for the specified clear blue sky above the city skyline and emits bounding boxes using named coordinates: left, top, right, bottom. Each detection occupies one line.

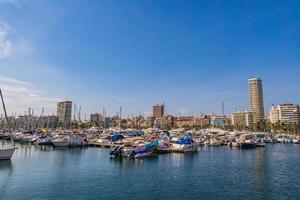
left=0, top=0, right=300, bottom=115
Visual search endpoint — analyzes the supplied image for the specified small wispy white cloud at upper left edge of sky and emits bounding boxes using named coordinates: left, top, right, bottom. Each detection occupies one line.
left=0, top=21, right=12, bottom=59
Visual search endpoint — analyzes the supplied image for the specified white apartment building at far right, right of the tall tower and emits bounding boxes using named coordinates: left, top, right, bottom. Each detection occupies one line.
left=269, top=103, right=300, bottom=124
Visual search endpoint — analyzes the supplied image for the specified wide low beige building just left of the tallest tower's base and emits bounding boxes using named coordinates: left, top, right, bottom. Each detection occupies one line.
left=231, top=111, right=256, bottom=128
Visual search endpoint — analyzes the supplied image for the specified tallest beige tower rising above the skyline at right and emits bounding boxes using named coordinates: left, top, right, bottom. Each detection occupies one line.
left=248, top=78, right=265, bottom=123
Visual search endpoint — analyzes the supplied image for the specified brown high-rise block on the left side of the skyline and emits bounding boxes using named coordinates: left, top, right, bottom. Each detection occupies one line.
left=57, top=101, right=72, bottom=128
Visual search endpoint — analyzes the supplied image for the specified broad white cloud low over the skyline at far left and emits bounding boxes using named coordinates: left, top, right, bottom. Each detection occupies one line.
left=0, top=75, right=60, bottom=114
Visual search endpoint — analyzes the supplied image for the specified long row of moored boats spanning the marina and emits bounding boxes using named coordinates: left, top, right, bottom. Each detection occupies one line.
left=0, top=128, right=300, bottom=161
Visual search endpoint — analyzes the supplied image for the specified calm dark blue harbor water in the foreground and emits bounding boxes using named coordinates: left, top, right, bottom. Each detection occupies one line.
left=0, top=144, right=300, bottom=200
